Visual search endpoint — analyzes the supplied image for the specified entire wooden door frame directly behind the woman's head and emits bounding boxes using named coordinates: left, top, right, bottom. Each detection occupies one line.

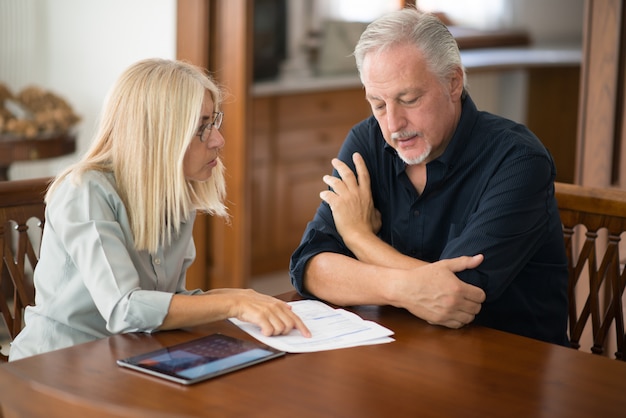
left=176, top=0, right=253, bottom=289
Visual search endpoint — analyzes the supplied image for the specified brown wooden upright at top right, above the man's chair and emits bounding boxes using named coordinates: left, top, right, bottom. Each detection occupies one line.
left=576, top=0, right=626, bottom=187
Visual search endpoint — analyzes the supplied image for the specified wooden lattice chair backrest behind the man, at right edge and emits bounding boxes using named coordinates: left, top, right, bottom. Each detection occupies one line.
left=555, top=183, right=626, bottom=360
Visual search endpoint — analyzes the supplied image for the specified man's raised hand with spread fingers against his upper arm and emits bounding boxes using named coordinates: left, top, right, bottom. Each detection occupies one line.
left=320, top=153, right=382, bottom=242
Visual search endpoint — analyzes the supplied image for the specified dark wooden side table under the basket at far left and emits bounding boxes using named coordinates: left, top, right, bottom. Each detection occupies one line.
left=0, top=134, right=76, bottom=181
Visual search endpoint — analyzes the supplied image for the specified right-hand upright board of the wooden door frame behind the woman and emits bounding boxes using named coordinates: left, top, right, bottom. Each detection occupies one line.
left=209, top=0, right=252, bottom=288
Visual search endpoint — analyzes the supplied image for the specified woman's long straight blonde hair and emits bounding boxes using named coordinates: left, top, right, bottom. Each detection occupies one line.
left=46, top=59, right=227, bottom=253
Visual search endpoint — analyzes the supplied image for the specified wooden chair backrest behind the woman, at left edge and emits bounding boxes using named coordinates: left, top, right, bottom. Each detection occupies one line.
left=0, top=178, right=51, bottom=361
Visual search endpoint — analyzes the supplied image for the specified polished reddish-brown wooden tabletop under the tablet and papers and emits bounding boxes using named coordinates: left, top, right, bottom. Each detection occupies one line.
left=0, top=293, right=626, bottom=418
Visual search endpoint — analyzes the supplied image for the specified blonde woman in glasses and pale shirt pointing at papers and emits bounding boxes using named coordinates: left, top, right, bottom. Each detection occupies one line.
left=10, top=59, right=310, bottom=361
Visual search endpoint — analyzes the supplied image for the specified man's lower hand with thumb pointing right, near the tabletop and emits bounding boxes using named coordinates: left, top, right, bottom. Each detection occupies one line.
left=394, top=255, right=485, bottom=328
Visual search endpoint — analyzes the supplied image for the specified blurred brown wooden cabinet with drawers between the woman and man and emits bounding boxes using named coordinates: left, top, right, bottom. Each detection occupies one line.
left=250, top=87, right=370, bottom=275
